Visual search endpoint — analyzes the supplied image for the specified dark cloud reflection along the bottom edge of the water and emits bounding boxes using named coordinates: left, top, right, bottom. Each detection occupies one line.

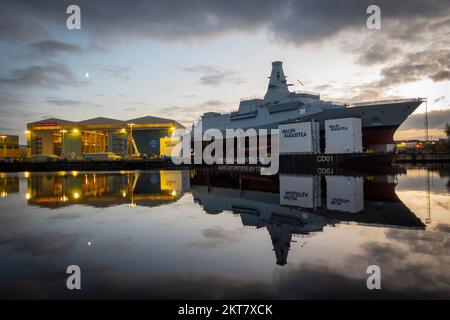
left=0, top=263, right=450, bottom=299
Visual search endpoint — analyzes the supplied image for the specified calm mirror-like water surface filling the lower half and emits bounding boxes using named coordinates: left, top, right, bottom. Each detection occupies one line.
left=0, top=166, right=450, bottom=299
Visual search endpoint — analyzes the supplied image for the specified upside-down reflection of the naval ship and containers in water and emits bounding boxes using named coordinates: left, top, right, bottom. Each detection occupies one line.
left=191, top=170, right=425, bottom=265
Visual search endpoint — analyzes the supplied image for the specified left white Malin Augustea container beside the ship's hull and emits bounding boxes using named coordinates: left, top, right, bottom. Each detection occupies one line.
left=278, top=121, right=320, bottom=154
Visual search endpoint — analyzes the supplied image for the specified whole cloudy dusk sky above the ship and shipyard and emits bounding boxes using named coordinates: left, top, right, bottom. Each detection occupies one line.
left=0, top=0, right=450, bottom=143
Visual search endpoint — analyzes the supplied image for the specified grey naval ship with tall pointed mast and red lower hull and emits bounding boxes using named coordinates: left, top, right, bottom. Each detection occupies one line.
left=197, top=61, right=425, bottom=151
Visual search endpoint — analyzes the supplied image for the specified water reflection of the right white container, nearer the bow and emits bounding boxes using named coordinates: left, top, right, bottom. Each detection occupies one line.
left=326, top=176, right=364, bottom=213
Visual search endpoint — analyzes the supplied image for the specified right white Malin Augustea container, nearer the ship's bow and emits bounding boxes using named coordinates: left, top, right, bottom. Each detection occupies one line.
left=325, top=118, right=362, bottom=154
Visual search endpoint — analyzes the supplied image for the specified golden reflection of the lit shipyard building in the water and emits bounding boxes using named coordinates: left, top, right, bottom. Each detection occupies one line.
left=27, top=170, right=189, bottom=208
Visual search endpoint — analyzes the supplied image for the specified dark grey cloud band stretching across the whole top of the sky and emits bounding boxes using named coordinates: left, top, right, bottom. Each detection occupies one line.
left=0, top=0, right=449, bottom=45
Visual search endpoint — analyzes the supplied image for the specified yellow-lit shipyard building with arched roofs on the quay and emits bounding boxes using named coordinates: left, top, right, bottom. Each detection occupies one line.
left=27, top=116, right=183, bottom=159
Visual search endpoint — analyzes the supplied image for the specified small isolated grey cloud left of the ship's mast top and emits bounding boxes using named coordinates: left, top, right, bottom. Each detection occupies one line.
left=181, top=65, right=244, bottom=87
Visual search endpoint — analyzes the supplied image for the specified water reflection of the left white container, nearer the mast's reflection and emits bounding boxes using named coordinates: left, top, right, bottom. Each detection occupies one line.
left=280, top=175, right=321, bottom=209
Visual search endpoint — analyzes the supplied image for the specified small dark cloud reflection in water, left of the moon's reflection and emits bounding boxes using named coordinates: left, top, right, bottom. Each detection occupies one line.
left=0, top=231, right=83, bottom=257
